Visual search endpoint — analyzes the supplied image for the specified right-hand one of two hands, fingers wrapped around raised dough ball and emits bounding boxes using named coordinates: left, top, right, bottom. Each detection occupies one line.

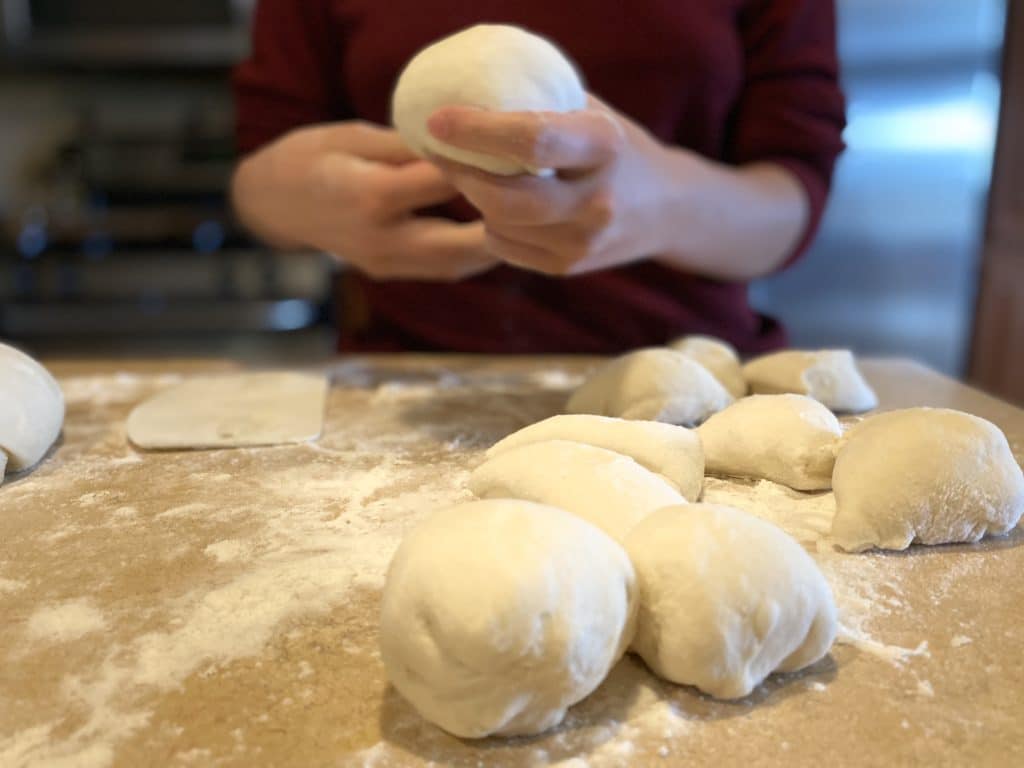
left=428, top=98, right=673, bottom=274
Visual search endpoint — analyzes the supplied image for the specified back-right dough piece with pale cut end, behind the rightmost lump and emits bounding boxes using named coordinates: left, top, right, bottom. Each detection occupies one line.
left=743, top=349, right=879, bottom=414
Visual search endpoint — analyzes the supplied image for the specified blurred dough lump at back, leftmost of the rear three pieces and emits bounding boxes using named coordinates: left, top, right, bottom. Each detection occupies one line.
left=566, top=348, right=732, bottom=426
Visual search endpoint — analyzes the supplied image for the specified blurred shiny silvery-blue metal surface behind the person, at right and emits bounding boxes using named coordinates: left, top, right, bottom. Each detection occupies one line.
left=752, top=0, right=1006, bottom=375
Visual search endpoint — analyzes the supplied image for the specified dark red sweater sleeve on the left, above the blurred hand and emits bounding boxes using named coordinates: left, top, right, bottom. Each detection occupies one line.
left=232, top=0, right=347, bottom=154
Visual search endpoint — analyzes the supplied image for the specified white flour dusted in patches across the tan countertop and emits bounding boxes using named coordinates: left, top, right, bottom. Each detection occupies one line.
left=0, top=362, right=970, bottom=768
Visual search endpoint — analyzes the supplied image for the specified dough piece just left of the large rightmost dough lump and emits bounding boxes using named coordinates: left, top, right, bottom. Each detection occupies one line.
left=697, top=394, right=843, bottom=490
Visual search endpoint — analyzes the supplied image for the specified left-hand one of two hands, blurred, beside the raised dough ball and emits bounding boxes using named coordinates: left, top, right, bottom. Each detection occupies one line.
left=231, top=122, right=497, bottom=281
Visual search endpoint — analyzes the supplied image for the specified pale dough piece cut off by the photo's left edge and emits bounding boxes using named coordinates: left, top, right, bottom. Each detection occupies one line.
left=0, top=344, right=65, bottom=479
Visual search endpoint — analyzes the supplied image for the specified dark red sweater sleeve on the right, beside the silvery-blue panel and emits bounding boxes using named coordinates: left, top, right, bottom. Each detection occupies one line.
left=727, top=0, right=846, bottom=264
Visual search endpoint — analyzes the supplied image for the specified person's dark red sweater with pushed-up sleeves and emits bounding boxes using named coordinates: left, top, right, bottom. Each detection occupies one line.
left=236, top=0, right=844, bottom=352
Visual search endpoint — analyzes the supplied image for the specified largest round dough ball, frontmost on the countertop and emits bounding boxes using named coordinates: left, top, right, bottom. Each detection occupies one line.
left=380, top=500, right=636, bottom=738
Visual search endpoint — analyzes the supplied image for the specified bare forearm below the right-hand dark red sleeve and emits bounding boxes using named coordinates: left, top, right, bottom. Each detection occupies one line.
left=655, top=150, right=810, bottom=281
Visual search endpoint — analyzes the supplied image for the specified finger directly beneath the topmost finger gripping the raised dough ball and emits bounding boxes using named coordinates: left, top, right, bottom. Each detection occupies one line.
left=431, top=158, right=596, bottom=226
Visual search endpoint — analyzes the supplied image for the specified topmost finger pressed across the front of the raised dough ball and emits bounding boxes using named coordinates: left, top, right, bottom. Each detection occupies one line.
left=427, top=106, right=624, bottom=169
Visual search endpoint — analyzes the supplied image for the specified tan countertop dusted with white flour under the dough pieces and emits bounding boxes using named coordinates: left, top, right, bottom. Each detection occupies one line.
left=0, top=357, right=1024, bottom=768
